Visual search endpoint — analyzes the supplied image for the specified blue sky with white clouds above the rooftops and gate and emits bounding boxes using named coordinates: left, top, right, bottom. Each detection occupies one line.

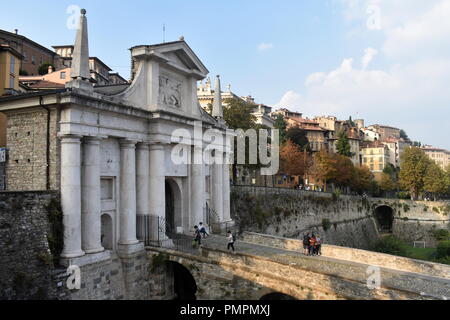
left=0, top=0, right=450, bottom=150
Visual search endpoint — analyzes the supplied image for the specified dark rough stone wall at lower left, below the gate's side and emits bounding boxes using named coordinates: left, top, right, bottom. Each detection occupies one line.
left=0, top=192, right=59, bottom=300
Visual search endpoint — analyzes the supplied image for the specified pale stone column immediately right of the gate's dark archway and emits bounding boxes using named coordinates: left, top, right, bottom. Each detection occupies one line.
left=190, top=146, right=205, bottom=227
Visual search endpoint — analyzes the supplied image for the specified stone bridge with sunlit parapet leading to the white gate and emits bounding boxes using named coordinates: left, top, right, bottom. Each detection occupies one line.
left=147, top=233, right=450, bottom=300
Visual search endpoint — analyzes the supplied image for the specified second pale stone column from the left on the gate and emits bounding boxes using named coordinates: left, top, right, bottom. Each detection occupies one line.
left=81, top=137, right=105, bottom=253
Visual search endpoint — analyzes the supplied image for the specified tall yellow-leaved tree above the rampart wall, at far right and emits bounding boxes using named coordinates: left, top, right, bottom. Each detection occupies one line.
left=399, top=147, right=431, bottom=200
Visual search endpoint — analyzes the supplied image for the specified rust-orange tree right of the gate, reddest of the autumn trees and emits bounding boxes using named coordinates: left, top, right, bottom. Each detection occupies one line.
left=280, top=140, right=310, bottom=176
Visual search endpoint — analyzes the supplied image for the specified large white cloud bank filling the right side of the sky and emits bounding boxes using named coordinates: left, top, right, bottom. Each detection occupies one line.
left=277, top=0, right=450, bottom=149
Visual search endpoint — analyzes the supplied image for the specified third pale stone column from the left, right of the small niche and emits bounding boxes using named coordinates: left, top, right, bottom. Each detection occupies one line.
left=119, top=140, right=139, bottom=246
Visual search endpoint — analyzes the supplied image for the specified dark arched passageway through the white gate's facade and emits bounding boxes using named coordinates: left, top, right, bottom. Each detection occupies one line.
left=165, top=178, right=183, bottom=233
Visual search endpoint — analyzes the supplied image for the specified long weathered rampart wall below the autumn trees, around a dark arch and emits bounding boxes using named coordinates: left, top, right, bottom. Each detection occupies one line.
left=231, top=186, right=450, bottom=249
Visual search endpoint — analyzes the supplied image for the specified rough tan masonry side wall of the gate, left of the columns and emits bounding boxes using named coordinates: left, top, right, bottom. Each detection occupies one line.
left=6, top=108, right=60, bottom=191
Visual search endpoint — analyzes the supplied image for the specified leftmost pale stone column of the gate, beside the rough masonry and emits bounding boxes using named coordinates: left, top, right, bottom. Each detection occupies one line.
left=61, top=135, right=84, bottom=259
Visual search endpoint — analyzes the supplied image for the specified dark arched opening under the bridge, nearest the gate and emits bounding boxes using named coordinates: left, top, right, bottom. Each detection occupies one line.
left=167, top=261, right=197, bottom=301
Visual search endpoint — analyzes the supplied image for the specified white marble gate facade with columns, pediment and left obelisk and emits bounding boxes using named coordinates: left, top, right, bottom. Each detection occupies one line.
left=59, top=14, right=231, bottom=259
